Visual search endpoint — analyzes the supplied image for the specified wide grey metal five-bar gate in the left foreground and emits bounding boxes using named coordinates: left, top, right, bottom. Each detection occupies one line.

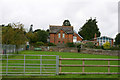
left=1, top=54, right=59, bottom=76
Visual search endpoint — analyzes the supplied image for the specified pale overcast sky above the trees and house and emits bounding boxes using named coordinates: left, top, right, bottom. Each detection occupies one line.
left=0, top=0, right=119, bottom=38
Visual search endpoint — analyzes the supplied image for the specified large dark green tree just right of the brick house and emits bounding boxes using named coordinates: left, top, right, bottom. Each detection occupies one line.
left=78, top=18, right=101, bottom=40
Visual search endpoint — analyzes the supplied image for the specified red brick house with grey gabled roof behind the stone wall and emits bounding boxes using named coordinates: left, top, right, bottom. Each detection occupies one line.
left=49, top=20, right=83, bottom=44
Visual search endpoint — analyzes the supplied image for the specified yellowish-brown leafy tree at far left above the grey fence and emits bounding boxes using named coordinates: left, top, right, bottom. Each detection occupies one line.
left=2, top=23, right=27, bottom=47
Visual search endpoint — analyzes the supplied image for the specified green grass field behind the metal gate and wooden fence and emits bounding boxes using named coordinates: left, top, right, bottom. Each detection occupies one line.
left=3, top=51, right=118, bottom=78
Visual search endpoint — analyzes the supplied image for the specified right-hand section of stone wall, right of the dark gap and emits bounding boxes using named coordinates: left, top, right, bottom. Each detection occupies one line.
left=80, top=49, right=119, bottom=56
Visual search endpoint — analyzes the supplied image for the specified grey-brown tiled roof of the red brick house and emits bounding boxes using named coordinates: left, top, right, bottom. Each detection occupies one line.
left=50, top=25, right=74, bottom=34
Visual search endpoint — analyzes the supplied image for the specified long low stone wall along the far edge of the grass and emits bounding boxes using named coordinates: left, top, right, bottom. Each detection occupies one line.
left=31, top=46, right=120, bottom=56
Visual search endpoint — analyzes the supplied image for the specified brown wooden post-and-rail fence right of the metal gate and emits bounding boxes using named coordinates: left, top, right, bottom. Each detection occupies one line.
left=59, top=57, right=120, bottom=74
